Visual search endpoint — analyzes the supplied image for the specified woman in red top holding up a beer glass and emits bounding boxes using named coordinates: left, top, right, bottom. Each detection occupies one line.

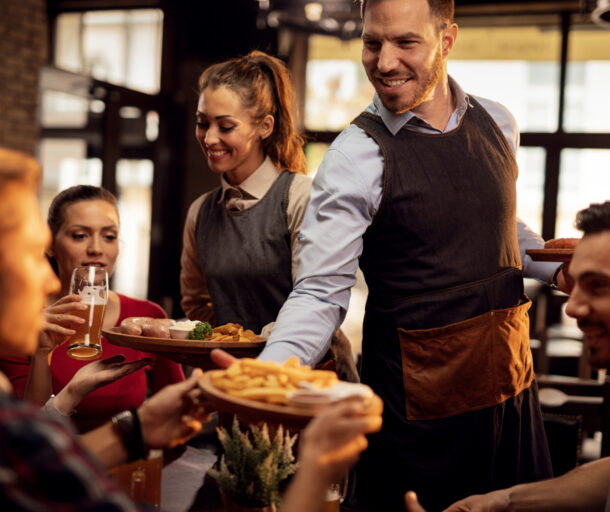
left=0, top=185, right=184, bottom=432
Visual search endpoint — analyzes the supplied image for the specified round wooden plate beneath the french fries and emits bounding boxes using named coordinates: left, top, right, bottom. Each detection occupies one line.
left=199, top=370, right=315, bottom=430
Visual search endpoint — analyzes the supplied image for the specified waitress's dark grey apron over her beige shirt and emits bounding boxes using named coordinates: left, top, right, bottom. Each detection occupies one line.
left=195, top=171, right=359, bottom=381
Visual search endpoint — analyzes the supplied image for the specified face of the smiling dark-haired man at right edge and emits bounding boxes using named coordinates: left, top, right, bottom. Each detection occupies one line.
left=566, top=231, right=610, bottom=368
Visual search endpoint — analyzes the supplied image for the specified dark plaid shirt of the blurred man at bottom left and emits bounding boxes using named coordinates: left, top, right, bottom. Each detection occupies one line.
left=0, top=392, right=144, bottom=512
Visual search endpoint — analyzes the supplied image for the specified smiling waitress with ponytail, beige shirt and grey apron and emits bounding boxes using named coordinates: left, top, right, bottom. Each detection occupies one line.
left=180, top=51, right=358, bottom=381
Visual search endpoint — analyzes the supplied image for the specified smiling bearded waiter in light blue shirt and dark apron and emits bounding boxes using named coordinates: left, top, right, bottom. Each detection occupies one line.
left=261, top=0, right=563, bottom=511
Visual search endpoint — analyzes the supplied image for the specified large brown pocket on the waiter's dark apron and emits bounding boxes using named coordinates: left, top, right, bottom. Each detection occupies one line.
left=398, top=300, right=534, bottom=420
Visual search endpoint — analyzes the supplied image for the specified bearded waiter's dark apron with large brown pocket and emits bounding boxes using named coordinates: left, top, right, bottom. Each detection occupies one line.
left=354, top=99, right=551, bottom=512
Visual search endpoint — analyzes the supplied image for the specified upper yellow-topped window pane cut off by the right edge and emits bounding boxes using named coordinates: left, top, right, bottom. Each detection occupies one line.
left=564, top=28, right=610, bottom=132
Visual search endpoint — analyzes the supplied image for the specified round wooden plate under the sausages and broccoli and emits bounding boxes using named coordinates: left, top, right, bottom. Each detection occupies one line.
left=102, top=327, right=267, bottom=370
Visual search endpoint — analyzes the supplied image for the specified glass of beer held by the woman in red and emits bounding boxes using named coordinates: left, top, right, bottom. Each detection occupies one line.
left=68, top=266, right=108, bottom=361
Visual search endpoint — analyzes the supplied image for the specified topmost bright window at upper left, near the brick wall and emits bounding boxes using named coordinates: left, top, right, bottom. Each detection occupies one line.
left=55, top=9, right=163, bottom=94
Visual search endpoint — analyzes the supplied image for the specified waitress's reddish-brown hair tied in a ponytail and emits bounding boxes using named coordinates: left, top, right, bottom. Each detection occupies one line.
left=199, top=51, right=307, bottom=174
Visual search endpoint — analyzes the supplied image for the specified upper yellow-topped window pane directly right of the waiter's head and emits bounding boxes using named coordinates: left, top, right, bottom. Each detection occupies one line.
left=447, top=21, right=561, bottom=132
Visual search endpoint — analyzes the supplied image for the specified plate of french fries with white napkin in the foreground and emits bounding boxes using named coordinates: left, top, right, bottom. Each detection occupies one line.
left=199, top=357, right=372, bottom=428
